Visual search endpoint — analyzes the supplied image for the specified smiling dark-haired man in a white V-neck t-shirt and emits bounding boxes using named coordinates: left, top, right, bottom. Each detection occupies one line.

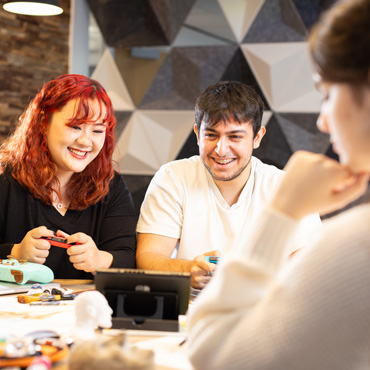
left=136, top=81, right=321, bottom=289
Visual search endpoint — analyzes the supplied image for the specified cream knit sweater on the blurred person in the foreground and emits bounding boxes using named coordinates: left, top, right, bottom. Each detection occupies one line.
left=188, top=205, right=370, bottom=370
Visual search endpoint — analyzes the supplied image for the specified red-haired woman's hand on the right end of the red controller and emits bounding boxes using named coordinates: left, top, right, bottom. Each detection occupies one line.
left=56, top=230, right=113, bottom=273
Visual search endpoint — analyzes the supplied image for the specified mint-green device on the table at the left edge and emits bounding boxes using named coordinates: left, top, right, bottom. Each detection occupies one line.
left=0, top=256, right=54, bottom=284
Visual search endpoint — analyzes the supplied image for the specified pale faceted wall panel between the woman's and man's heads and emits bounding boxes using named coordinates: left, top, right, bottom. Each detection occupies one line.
left=113, top=110, right=194, bottom=175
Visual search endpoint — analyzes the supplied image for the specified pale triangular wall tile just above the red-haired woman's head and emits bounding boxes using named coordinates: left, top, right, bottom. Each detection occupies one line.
left=91, top=49, right=135, bottom=111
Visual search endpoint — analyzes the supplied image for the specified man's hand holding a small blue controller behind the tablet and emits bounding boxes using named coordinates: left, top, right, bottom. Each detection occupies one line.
left=190, top=250, right=221, bottom=289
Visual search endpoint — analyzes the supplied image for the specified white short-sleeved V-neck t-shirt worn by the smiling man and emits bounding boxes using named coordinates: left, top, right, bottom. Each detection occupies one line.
left=137, top=156, right=321, bottom=260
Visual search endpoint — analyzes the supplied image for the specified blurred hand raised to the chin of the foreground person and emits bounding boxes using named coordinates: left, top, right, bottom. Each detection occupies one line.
left=271, top=151, right=369, bottom=220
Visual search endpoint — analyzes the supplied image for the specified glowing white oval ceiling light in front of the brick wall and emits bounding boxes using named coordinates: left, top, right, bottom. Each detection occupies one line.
left=3, top=0, right=63, bottom=16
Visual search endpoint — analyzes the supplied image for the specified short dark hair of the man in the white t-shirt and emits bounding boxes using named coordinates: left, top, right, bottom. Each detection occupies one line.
left=195, top=81, right=264, bottom=137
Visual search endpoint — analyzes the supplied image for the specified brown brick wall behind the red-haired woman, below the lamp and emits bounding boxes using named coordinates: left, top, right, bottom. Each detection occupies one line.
left=0, top=0, right=70, bottom=142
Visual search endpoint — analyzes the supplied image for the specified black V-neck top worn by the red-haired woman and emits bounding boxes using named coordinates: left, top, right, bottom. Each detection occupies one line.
left=0, top=171, right=136, bottom=279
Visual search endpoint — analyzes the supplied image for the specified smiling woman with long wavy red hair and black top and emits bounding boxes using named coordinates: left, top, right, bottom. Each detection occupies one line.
left=0, top=74, right=136, bottom=279
